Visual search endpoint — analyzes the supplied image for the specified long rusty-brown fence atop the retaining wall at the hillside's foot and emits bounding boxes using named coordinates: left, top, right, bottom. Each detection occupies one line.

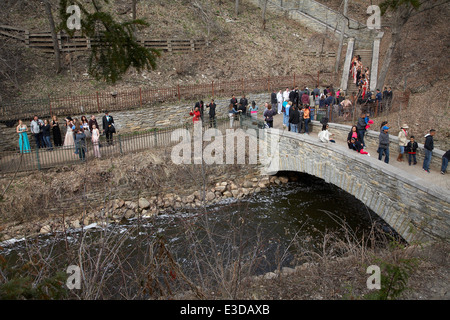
left=0, top=72, right=331, bottom=123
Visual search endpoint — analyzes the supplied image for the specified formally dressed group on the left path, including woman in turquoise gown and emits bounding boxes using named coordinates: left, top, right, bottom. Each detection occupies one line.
left=16, top=111, right=116, bottom=161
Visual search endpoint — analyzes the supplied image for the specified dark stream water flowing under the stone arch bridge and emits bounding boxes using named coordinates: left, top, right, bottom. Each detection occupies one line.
left=0, top=174, right=400, bottom=296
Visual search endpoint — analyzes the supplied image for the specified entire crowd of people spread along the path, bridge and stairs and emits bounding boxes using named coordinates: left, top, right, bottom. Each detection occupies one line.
left=16, top=87, right=450, bottom=174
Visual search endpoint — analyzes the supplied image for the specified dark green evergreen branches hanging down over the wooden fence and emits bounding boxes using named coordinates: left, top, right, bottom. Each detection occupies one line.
left=59, top=0, right=161, bottom=83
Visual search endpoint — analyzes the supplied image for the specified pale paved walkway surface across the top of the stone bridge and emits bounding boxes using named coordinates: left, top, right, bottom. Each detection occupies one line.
left=261, top=114, right=450, bottom=193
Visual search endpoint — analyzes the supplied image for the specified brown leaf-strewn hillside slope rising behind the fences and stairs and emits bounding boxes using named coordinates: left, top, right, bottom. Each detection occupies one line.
left=0, top=0, right=450, bottom=149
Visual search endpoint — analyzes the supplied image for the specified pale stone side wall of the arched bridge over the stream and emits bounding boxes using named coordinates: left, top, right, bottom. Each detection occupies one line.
left=267, top=130, right=450, bottom=243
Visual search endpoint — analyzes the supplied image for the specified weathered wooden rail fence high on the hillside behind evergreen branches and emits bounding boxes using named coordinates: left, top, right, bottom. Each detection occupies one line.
left=0, top=25, right=209, bottom=53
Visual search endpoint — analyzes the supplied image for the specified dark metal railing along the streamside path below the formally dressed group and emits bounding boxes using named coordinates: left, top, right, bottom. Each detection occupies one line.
left=0, top=116, right=264, bottom=173
